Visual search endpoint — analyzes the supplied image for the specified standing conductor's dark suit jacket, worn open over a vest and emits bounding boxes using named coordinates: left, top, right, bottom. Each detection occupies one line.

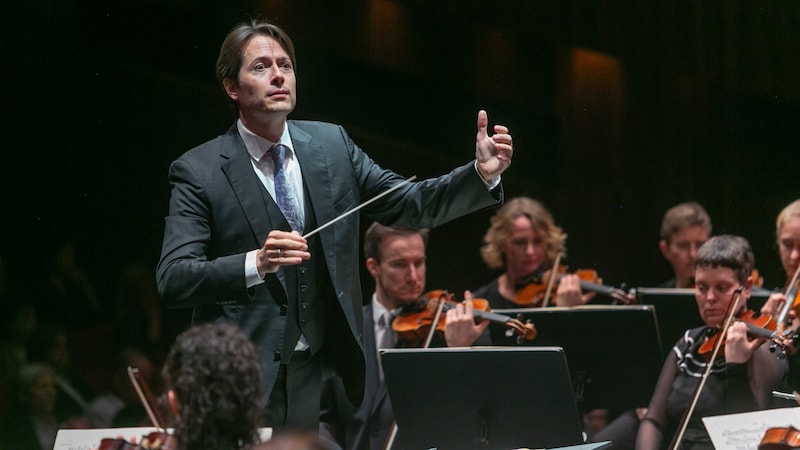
left=156, top=121, right=502, bottom=403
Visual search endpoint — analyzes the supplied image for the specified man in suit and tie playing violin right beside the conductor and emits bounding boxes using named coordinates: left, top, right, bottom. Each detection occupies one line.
left=320, top=222, right=490, bottom=450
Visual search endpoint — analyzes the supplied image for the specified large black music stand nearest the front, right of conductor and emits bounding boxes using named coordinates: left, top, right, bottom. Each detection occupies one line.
left=381, top=347, right=584, bottom=450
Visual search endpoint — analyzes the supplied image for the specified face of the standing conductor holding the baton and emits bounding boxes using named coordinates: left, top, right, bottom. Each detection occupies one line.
left=224, top=35, right=297, bottom=128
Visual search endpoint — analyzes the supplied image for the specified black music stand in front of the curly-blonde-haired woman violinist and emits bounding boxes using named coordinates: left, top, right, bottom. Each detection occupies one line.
left=491, top=305, right=664, bottom=411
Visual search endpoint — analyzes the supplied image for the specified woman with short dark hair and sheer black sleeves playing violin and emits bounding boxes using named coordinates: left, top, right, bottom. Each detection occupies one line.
left=636, top=235, right=786, bottom=449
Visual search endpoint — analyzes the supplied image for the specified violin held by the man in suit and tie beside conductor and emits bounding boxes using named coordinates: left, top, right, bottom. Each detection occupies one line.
left=392, top=289, right=536, bottom=342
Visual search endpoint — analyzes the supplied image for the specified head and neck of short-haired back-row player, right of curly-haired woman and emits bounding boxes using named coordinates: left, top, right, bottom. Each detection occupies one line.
left=658, top=202, right=711, bottom=288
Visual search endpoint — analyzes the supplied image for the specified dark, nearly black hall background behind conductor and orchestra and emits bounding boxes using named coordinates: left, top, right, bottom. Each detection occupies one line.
left=0, top=0, right=800, bottom=326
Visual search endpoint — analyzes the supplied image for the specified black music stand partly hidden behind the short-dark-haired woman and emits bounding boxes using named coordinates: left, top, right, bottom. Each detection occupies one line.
left=636, top=288, right=771, bottom=355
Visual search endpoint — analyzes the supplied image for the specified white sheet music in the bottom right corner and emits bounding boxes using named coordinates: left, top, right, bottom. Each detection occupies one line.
left=703, top=407, right=800, bottom=450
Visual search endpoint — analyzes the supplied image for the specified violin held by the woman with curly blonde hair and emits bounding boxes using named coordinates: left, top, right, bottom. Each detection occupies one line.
left=512, top=265, right=636, bottom=308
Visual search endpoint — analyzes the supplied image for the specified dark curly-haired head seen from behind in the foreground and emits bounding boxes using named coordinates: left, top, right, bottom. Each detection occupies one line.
left=163, top=322, right=263, bottom=450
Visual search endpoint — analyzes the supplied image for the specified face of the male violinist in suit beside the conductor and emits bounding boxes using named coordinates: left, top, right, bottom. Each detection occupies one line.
left=367, top=234, right=425, bottom=309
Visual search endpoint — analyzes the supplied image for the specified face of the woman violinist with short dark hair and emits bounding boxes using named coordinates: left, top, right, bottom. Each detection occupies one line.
left=694, top=267, right=751, bottom=327
